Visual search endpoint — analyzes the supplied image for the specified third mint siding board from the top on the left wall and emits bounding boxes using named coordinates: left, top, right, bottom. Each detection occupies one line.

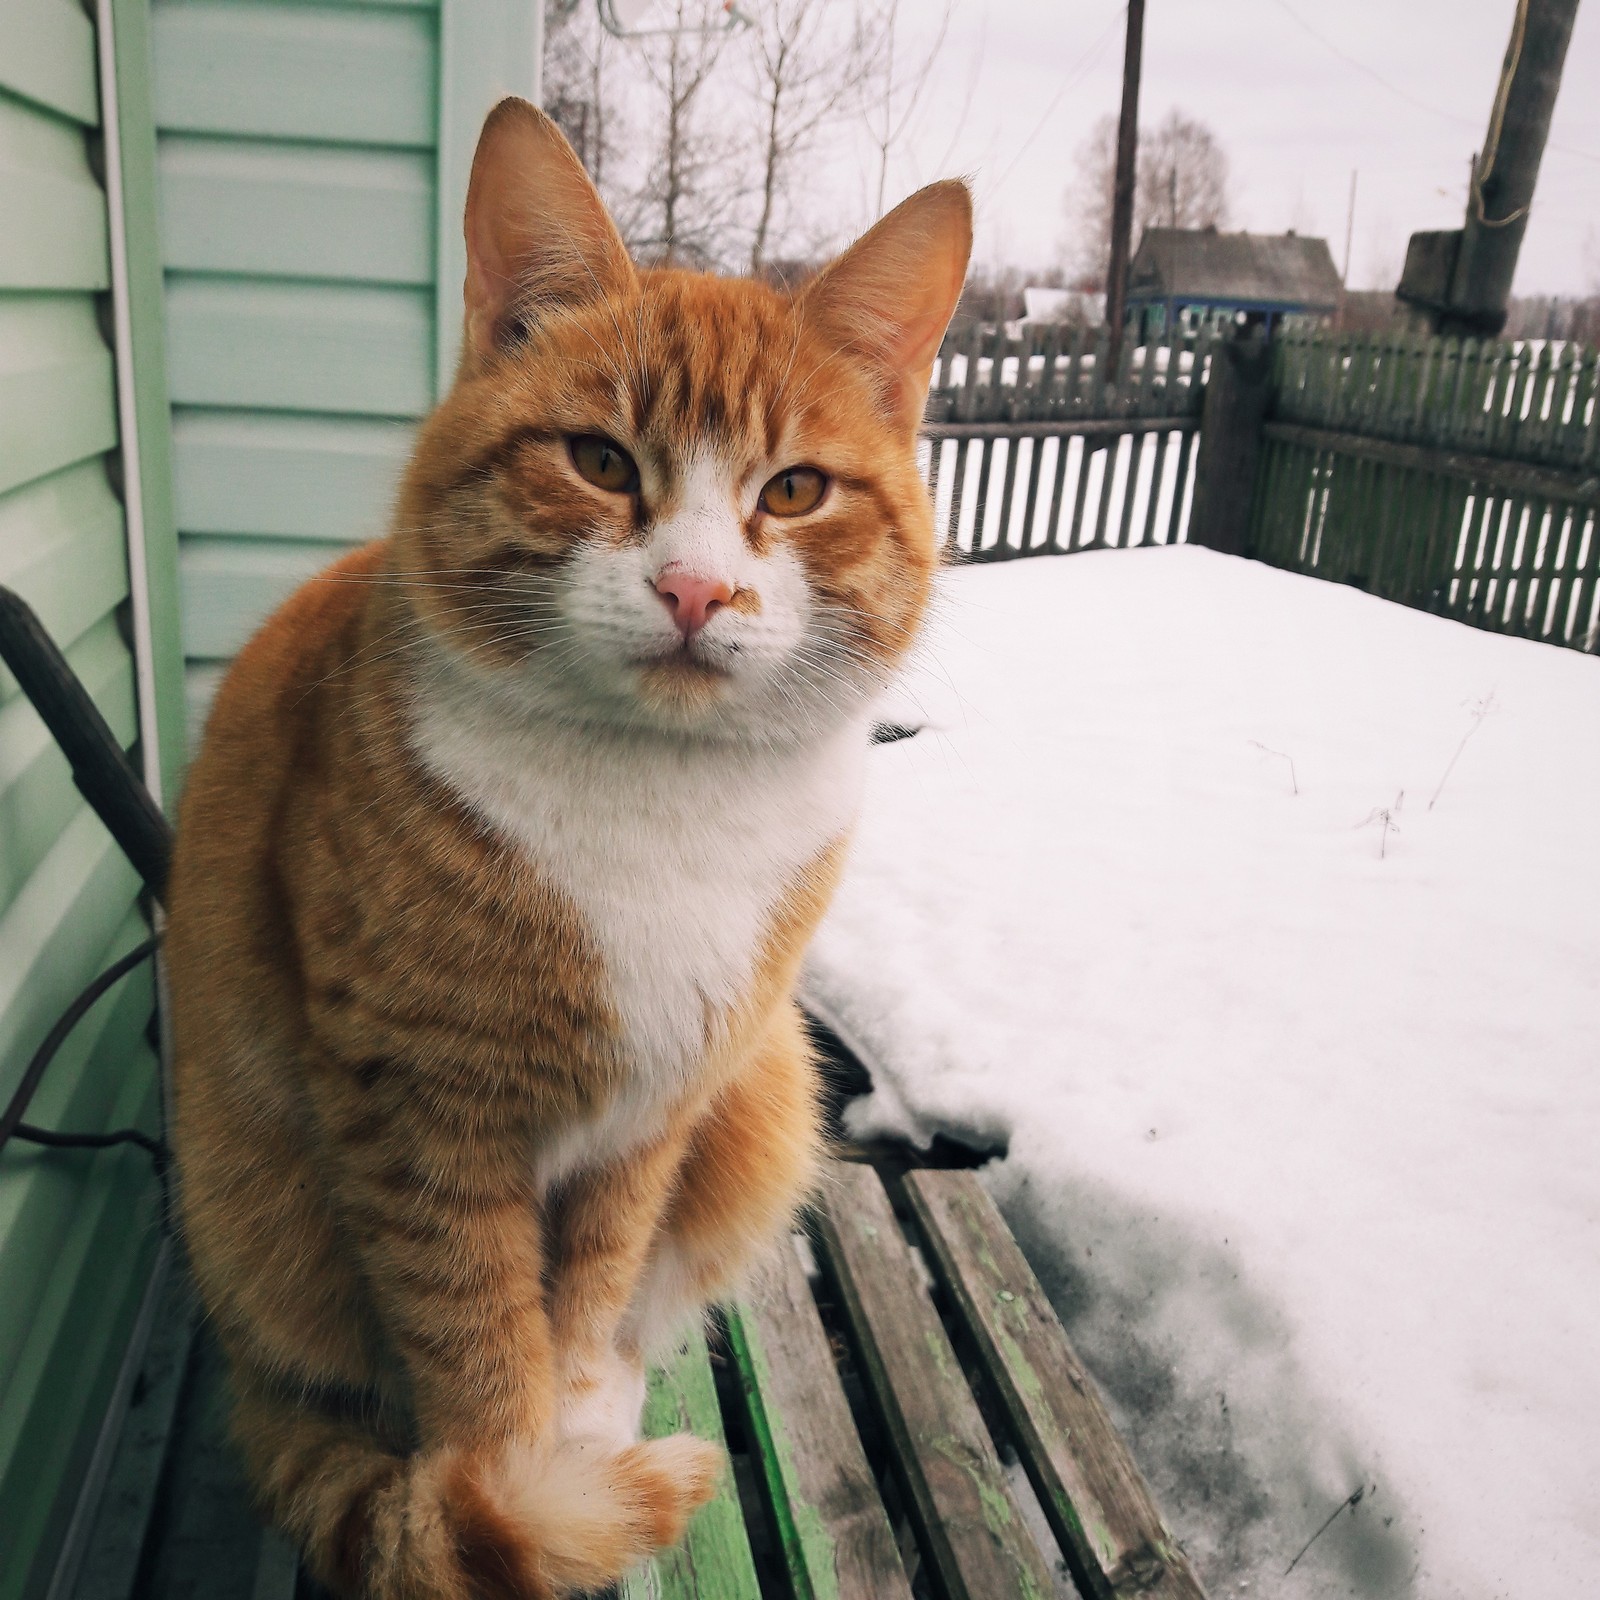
left=0, top=294, right=117, bottom=494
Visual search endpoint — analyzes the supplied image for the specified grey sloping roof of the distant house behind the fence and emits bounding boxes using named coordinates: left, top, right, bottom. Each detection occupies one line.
left=1128, top=227, right=1339, bottom=310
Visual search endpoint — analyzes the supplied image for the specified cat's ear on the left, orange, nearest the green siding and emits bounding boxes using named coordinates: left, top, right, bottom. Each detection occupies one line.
left=462, top=98, right=635, bottom=366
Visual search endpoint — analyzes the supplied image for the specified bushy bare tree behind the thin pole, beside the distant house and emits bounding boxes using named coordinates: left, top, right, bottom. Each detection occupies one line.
left=1067, top=110, right=1227, bottom=290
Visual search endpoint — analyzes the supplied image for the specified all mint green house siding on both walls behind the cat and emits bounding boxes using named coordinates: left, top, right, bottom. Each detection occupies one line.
left=0, top=0, right=539, bottom=1600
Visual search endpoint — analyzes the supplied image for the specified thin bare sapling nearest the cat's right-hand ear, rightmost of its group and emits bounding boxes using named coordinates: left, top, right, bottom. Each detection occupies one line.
left=750, top=0, right=877, bottom=275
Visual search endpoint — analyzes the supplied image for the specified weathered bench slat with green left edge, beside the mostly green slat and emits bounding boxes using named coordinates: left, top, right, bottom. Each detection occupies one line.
left=728, top=1250, right=910, bottom=1600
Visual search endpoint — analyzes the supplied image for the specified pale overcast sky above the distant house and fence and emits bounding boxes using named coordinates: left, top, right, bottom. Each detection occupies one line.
left=870, top=0, right=1600, bottom=294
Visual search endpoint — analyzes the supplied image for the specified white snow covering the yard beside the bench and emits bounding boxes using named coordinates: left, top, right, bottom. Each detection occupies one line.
left=805, top=547, right=1600, bottom=1600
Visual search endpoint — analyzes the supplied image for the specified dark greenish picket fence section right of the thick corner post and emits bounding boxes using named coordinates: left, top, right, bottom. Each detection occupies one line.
left=1245, top=330, right=1600, bottom=651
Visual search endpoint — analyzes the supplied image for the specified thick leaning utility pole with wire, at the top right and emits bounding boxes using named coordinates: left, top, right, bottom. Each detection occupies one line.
left=1397, top=0, right=1578, bottom=336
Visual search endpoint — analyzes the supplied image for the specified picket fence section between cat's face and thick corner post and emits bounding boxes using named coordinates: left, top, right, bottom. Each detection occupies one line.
left=923, top=326, right=1210, bottom=562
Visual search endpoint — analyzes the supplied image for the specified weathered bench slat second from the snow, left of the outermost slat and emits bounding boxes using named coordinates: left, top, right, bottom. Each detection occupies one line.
left=821, top=1165, right=1051, bottom=1600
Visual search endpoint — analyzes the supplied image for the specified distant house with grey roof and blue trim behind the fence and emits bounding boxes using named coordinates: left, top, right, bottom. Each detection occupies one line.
left=1128, top=227, right=1342, bottom=338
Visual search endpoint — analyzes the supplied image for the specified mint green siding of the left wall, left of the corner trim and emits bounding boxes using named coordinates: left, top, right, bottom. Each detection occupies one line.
left=0, top=0, right=157, bottom=1600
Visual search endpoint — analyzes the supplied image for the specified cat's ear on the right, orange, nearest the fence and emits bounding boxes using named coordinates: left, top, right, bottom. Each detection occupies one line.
left=802, top=179, right=973, bottom=427
